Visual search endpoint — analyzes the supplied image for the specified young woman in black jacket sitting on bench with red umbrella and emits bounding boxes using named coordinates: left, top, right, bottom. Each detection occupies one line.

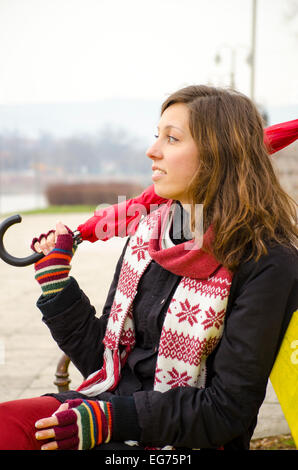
left=0, top=86, right=298, bottom=450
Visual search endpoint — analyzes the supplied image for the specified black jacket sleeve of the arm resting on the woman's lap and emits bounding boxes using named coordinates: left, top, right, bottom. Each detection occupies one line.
left=134, top=247, right=298, bottom=448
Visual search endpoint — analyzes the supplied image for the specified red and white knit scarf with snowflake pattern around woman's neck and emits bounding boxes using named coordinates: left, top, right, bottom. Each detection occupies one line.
left=78, top=200, right=232, bottom=396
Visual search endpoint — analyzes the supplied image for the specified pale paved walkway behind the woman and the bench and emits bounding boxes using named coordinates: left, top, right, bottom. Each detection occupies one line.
left=0, top=214, right=290, bottom=438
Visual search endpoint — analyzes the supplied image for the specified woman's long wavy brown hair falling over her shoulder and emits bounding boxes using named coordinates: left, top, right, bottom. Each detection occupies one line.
left=161, top=85, right=297, bottom=271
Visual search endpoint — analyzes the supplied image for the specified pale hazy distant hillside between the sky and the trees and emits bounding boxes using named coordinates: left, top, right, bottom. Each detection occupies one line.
left=0, top=99, right=298, bottom=141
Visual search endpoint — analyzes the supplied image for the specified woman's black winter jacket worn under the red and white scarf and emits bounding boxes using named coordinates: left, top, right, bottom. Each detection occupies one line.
left=37, top=233, right=298, bottom=450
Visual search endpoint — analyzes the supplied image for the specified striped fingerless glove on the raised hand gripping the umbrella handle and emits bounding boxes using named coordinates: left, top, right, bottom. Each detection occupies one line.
left=34, top=233, right=76, bottom=295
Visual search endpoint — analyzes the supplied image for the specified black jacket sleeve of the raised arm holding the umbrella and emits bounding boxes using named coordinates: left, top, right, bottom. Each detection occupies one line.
left=37, top=240, right=128, bottom=377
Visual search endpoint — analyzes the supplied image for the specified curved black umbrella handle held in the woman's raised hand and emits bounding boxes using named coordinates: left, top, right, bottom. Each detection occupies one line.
left=0, top=214, right=82, bottom=267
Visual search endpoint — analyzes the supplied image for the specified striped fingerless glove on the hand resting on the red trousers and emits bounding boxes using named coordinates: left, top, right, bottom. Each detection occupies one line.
left=54, top=399, right=112, bottom=450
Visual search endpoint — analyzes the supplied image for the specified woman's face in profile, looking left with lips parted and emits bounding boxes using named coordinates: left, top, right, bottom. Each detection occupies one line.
left=146, top=103, right=199, bottom=204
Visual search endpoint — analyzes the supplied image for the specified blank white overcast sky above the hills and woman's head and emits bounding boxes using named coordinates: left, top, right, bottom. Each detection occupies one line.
left=0, top=0, right=298, bottom=106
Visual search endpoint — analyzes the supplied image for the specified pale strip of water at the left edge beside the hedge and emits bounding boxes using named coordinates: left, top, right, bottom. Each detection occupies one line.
left=0, top=193, right=48, bottom=214
